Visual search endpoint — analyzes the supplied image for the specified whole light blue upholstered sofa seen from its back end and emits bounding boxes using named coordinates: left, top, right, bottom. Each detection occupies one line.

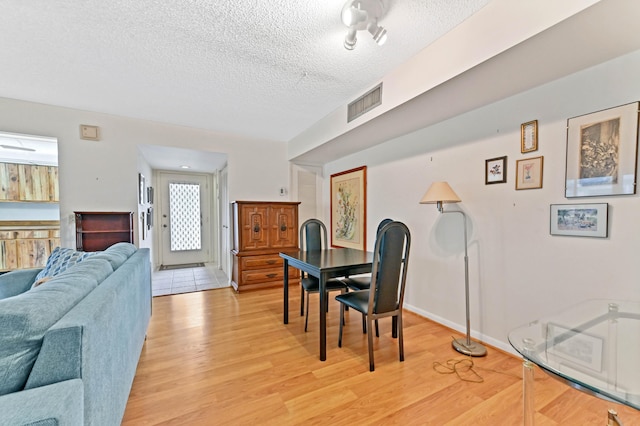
left=0, top=243, right=151, bottom=426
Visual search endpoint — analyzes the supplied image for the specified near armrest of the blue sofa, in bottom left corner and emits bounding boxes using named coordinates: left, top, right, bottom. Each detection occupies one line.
left=0, top=379, right=84, bottom=426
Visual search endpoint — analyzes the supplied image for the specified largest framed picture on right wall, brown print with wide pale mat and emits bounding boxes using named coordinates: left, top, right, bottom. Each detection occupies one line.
left=565, top=102, right=639, bottom=198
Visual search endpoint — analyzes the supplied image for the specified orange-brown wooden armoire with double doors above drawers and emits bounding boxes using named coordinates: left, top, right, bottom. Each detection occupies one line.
left=231, top=201, right=300, bottom=292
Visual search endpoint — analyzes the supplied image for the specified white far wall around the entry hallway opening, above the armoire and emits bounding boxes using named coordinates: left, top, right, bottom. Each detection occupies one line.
left=0, top=98, right=289, bottom=247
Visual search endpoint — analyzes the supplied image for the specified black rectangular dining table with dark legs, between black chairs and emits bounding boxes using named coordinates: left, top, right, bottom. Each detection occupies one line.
left=280, top=248, right=373, bottom=361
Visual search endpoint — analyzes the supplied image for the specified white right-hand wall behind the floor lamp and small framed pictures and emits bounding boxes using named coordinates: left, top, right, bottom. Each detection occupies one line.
left=323, top=51, right=640, bottom=351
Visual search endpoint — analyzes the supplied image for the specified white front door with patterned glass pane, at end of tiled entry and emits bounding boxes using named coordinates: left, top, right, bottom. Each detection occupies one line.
left=158, top=172, right=211, bottom=265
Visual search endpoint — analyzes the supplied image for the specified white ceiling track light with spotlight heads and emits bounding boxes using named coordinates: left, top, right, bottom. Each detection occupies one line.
left=340, top=0, right=387, bottom=50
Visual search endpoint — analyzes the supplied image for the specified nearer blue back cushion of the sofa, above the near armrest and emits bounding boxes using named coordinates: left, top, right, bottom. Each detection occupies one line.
left=0, top=273, right=98, bottom=395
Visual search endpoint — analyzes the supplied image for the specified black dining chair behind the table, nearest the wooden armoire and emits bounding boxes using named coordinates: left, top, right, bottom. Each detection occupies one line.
left=300, top=219, right=348, bottom=332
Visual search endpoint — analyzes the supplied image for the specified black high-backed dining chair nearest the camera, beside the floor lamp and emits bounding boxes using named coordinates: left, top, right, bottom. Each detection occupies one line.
left=336, top=222, right=411, bottom=371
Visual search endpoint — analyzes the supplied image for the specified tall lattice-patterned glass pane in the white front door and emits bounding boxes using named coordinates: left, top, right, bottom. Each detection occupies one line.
left=169, top=183, right=202, bottom=251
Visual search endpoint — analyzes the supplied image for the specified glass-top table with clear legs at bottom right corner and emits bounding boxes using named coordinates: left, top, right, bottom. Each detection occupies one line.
left=509, top=300, right=640, bottom=417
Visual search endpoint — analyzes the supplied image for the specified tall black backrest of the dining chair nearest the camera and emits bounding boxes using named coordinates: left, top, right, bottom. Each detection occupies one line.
left=369, top=222, right=411, bottom=314
